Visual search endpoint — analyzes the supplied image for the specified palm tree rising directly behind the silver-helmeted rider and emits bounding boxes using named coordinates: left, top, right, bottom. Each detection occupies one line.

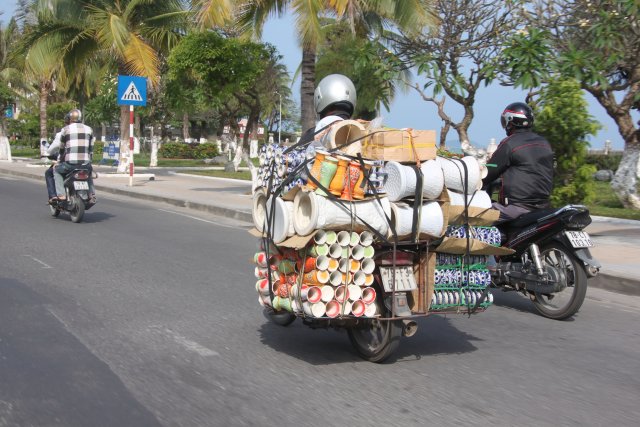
left=195, top=0, right=433, bottom=129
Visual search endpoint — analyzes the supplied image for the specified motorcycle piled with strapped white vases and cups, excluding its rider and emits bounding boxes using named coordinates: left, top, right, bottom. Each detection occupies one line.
left=252, top=120, right=513, bottom=362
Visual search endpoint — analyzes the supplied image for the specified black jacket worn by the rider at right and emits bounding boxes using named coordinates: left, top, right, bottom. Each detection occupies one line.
left=483, top=129, right=553, bottom=209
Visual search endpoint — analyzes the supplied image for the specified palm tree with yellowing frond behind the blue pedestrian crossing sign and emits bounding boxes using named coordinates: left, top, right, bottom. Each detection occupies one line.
left=23, top=0, right=186, bottom=170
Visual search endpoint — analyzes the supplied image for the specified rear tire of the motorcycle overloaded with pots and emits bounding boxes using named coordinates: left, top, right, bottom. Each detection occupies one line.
left=347, top=289, right=402, bottom=363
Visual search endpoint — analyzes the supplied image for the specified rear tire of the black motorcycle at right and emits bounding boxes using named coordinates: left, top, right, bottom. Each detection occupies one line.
left=533, top=241, right=587, bottom=320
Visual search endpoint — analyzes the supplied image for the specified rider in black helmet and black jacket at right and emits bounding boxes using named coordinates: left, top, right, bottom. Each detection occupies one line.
left=483, top=102, right=553, bottom=221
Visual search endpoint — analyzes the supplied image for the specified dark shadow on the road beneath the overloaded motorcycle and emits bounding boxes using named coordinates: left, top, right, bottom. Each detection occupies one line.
left=259, top=315, right=479, bottom=365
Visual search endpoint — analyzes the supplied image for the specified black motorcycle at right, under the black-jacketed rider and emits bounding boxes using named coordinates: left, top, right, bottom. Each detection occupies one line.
left=492, top=205, right=600, bottom=320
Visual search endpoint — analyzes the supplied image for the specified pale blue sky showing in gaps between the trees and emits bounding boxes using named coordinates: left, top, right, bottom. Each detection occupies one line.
left=0, top=0, right=640, bottom=150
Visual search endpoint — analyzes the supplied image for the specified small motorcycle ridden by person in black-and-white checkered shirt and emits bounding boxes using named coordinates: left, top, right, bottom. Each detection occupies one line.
left=49, top=162, right=95, bottom=223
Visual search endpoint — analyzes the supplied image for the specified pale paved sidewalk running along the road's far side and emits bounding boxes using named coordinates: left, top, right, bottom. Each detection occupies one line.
left=0, top=159, right=640, bottom=295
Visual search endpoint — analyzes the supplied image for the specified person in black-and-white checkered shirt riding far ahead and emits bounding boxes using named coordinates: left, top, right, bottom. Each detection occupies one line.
left=53, top=109, right=95, bottom=203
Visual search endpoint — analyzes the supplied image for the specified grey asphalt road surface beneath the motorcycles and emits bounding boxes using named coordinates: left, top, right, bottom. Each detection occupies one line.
left=0, top=175, right=640, bottom=427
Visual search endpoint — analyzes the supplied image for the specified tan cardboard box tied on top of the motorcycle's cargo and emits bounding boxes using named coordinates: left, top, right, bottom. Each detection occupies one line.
left=362, top=129, right=436, bottom=163
